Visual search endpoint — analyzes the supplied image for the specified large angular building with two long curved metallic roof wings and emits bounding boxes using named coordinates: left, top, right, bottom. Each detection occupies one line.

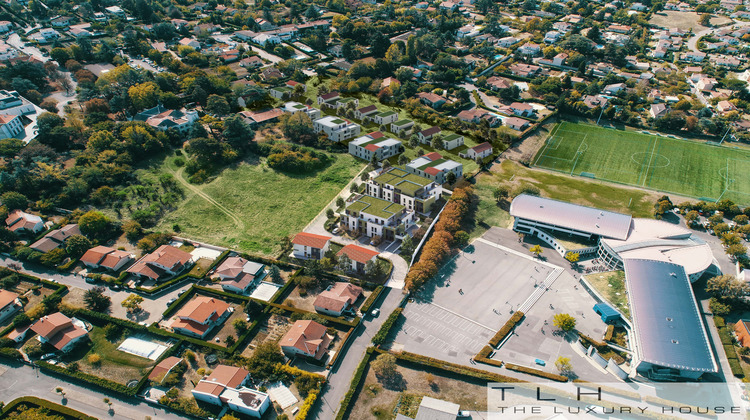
left=510, top=195, right=720, bottom=380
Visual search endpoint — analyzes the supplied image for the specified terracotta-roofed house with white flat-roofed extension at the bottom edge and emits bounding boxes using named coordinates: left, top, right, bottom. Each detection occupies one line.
left=191, top=365, right=271, bottom=418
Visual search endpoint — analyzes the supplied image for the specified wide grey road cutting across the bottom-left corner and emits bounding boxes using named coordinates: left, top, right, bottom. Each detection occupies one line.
left=0, top=363, right=185, bottom=420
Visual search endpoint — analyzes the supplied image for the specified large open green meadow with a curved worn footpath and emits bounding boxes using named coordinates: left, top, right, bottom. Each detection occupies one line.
left=157, top=154, right=365, bottom=256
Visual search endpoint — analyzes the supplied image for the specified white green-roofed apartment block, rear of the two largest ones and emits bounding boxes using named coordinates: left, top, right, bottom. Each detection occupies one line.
left=365, top=167, right=443, bottom=213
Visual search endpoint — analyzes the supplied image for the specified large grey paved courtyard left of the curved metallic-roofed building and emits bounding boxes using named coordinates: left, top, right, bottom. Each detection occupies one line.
left=393, top=228, right=614, bottom=380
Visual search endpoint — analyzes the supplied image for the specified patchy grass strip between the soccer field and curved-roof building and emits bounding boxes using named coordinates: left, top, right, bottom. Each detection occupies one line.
left=471, top=160, right=658, bottom=238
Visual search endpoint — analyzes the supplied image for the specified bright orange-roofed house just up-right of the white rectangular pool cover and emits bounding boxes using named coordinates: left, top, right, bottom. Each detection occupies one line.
left=171, top=296, right=233, bottom=338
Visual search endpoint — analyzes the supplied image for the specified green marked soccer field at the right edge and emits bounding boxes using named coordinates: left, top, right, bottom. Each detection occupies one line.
left=533, top=122, right=750, bottom=205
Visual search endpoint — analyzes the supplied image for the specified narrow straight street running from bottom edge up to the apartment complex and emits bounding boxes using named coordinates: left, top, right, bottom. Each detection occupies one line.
left=313, top=288, right=404, bottom=420
